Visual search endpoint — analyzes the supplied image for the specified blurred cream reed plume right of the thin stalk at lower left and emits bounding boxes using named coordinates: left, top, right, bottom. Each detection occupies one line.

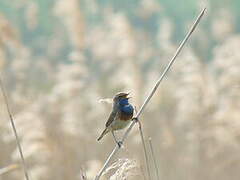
left=7, top=102, right=51, bottom=177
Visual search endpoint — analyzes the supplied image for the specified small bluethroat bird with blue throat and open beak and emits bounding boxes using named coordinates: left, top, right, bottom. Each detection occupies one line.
left=97, top=92, right=134, bottom=147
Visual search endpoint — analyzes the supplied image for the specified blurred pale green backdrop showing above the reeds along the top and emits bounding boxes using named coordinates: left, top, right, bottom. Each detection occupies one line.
left=0, top=0, right=240, bottom=60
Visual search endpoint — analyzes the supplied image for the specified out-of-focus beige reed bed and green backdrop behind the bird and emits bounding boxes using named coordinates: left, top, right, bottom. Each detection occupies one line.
left=0, top=0, right=240, bottom=180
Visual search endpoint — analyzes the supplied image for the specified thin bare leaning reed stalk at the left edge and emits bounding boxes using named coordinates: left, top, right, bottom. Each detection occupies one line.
left=0, top=78, right=29, bottom=180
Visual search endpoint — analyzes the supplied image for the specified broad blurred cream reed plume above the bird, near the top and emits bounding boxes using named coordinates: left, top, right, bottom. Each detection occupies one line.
left=86, top=11, right=137, bottom=63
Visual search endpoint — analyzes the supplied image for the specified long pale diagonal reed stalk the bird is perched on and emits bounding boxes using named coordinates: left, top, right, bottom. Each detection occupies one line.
left=95, top=8, right=206, bottom=180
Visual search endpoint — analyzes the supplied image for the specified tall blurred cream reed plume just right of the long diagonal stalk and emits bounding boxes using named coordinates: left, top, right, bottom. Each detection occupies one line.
left=173, top=50, right=205, bottom=127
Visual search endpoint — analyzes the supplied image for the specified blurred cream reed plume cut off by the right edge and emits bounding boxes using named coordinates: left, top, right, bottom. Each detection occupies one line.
left=213, top=35, right=240, bottom=107
